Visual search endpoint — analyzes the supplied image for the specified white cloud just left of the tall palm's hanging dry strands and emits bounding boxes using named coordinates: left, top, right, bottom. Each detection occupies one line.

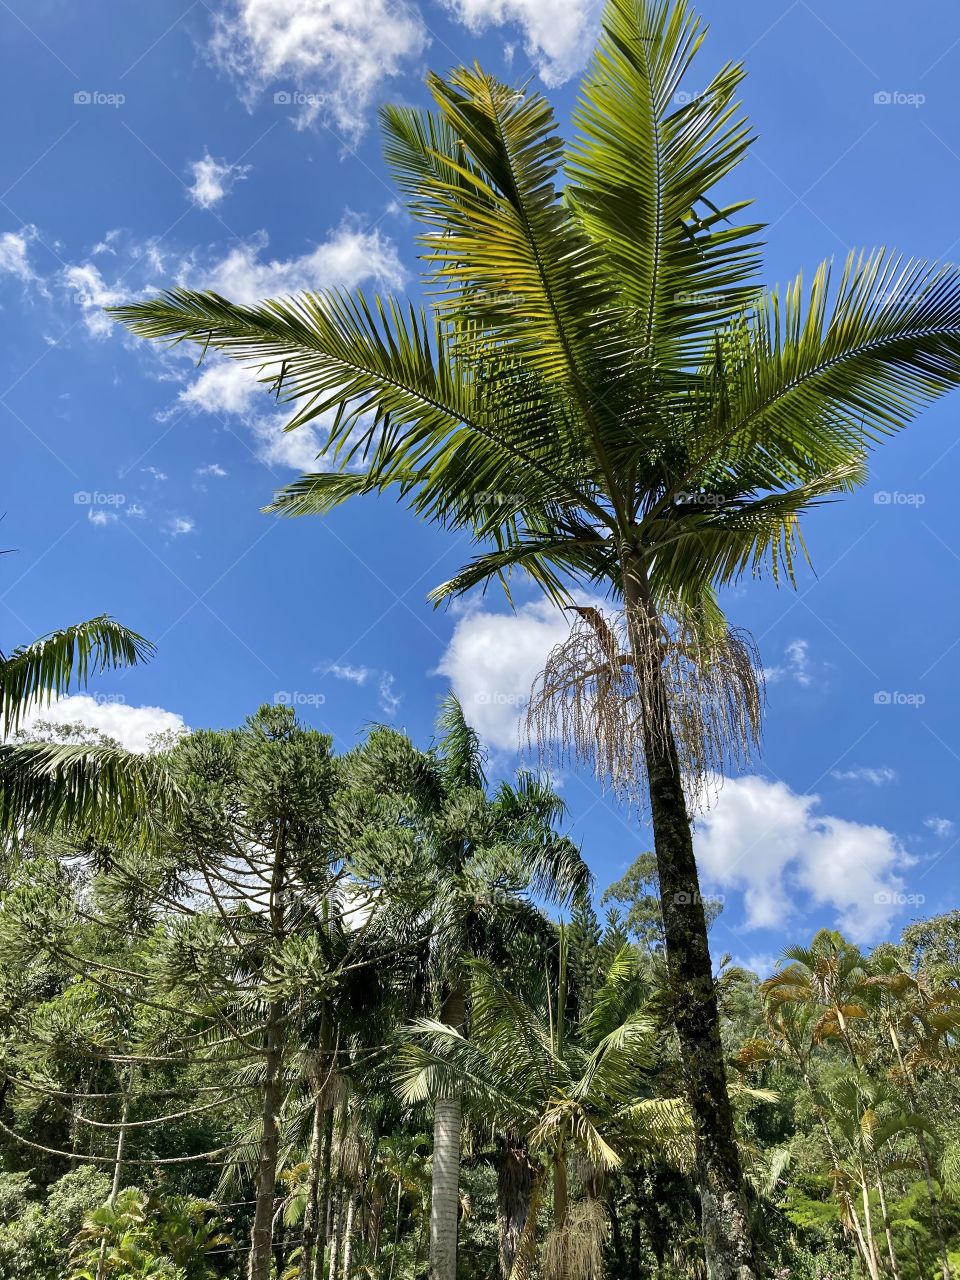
left=436, top=600, right=586, bottom=751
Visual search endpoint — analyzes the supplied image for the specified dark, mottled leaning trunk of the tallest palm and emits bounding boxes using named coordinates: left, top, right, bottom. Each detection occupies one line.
left=623, top=557, right=760, bottom=1280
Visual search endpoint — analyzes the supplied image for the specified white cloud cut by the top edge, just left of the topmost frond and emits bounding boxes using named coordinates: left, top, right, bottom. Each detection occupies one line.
left=442, top=0, right=600, bottom=86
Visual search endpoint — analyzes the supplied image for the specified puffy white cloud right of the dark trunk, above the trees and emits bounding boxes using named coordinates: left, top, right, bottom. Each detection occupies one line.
left=694, top=777, right=913, bottom=942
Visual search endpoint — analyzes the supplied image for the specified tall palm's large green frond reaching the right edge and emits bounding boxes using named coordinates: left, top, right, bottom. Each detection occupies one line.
left=717, top=251, right=960, bottom=470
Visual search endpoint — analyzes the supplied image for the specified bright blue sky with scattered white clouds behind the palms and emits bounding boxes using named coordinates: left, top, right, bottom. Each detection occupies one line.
left=0, top=0, right=960, bottom=966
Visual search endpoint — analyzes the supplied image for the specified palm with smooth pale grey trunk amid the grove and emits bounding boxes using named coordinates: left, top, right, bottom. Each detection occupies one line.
left=348, top=695, right=590, bottom=1280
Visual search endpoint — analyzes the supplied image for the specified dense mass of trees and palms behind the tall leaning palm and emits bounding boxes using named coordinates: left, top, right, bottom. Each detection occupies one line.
left=0, top=701, right=960, bottom=1280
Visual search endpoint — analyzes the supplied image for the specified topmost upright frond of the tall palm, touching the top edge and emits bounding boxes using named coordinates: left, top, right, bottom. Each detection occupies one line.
left=570, top=0, right=760, bottom=370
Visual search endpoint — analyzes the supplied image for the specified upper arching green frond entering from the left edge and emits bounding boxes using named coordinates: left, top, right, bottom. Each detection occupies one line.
left=0, top=614, right=154, bottom=733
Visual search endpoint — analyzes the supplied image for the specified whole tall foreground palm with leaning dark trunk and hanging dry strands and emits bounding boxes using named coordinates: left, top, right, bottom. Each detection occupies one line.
left=115, top=0, right=960, bottom=1280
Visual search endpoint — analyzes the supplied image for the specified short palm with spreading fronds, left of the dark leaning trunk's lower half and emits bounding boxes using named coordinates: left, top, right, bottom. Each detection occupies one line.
left=398, top=931, right=689, bottom=1280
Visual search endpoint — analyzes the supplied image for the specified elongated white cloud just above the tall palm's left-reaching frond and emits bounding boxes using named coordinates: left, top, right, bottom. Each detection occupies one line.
left=189, top=221, right=407, bottom=306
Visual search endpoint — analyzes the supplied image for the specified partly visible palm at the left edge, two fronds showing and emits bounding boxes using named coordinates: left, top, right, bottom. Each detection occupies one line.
left=0, top=614, right=177, bottom=837
